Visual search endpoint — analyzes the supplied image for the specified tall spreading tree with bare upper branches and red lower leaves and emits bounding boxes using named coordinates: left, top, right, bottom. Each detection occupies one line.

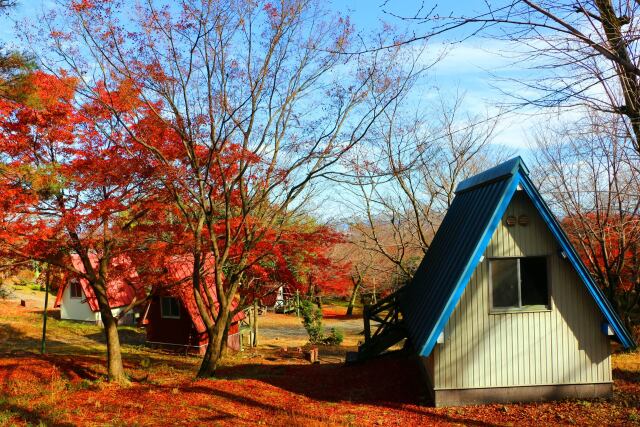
left=36, top=0, right=420, bottom=376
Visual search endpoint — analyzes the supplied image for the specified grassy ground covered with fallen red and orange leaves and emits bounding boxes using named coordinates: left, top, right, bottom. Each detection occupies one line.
left=0, top=301, right=640, bottom=426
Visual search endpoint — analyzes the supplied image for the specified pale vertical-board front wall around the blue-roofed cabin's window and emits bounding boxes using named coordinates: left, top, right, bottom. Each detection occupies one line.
left=433, top=191, right=611, bottom=389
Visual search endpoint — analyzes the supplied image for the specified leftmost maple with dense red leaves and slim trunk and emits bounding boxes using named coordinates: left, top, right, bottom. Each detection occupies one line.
left=0, top=72, right=158, bottom=381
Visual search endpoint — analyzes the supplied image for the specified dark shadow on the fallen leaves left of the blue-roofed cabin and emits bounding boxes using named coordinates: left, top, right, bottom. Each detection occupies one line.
left=180, top=352, right=492, bottom=426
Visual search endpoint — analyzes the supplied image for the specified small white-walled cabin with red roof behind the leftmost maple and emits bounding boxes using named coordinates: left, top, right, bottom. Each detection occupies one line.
left=54, top=254, right=145, bottom=325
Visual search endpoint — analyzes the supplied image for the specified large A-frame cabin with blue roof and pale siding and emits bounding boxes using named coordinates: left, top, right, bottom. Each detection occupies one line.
left=360, top=157, right=635, bottom=406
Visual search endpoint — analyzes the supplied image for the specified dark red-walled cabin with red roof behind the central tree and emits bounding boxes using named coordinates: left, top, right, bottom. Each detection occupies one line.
left=142, top=261, right=245, bottom=354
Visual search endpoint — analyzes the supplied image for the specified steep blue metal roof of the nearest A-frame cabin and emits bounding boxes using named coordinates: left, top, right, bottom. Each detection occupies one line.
left=401, top=157, right=635, bottom=356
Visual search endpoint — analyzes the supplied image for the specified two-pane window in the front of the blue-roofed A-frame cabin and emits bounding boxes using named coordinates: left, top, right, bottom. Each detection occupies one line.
left=489, top=257, right=549, bottom=311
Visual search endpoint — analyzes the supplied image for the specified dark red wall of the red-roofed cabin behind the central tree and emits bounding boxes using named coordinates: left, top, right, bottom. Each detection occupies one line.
left=144, top=297, right=240, bottom=354
